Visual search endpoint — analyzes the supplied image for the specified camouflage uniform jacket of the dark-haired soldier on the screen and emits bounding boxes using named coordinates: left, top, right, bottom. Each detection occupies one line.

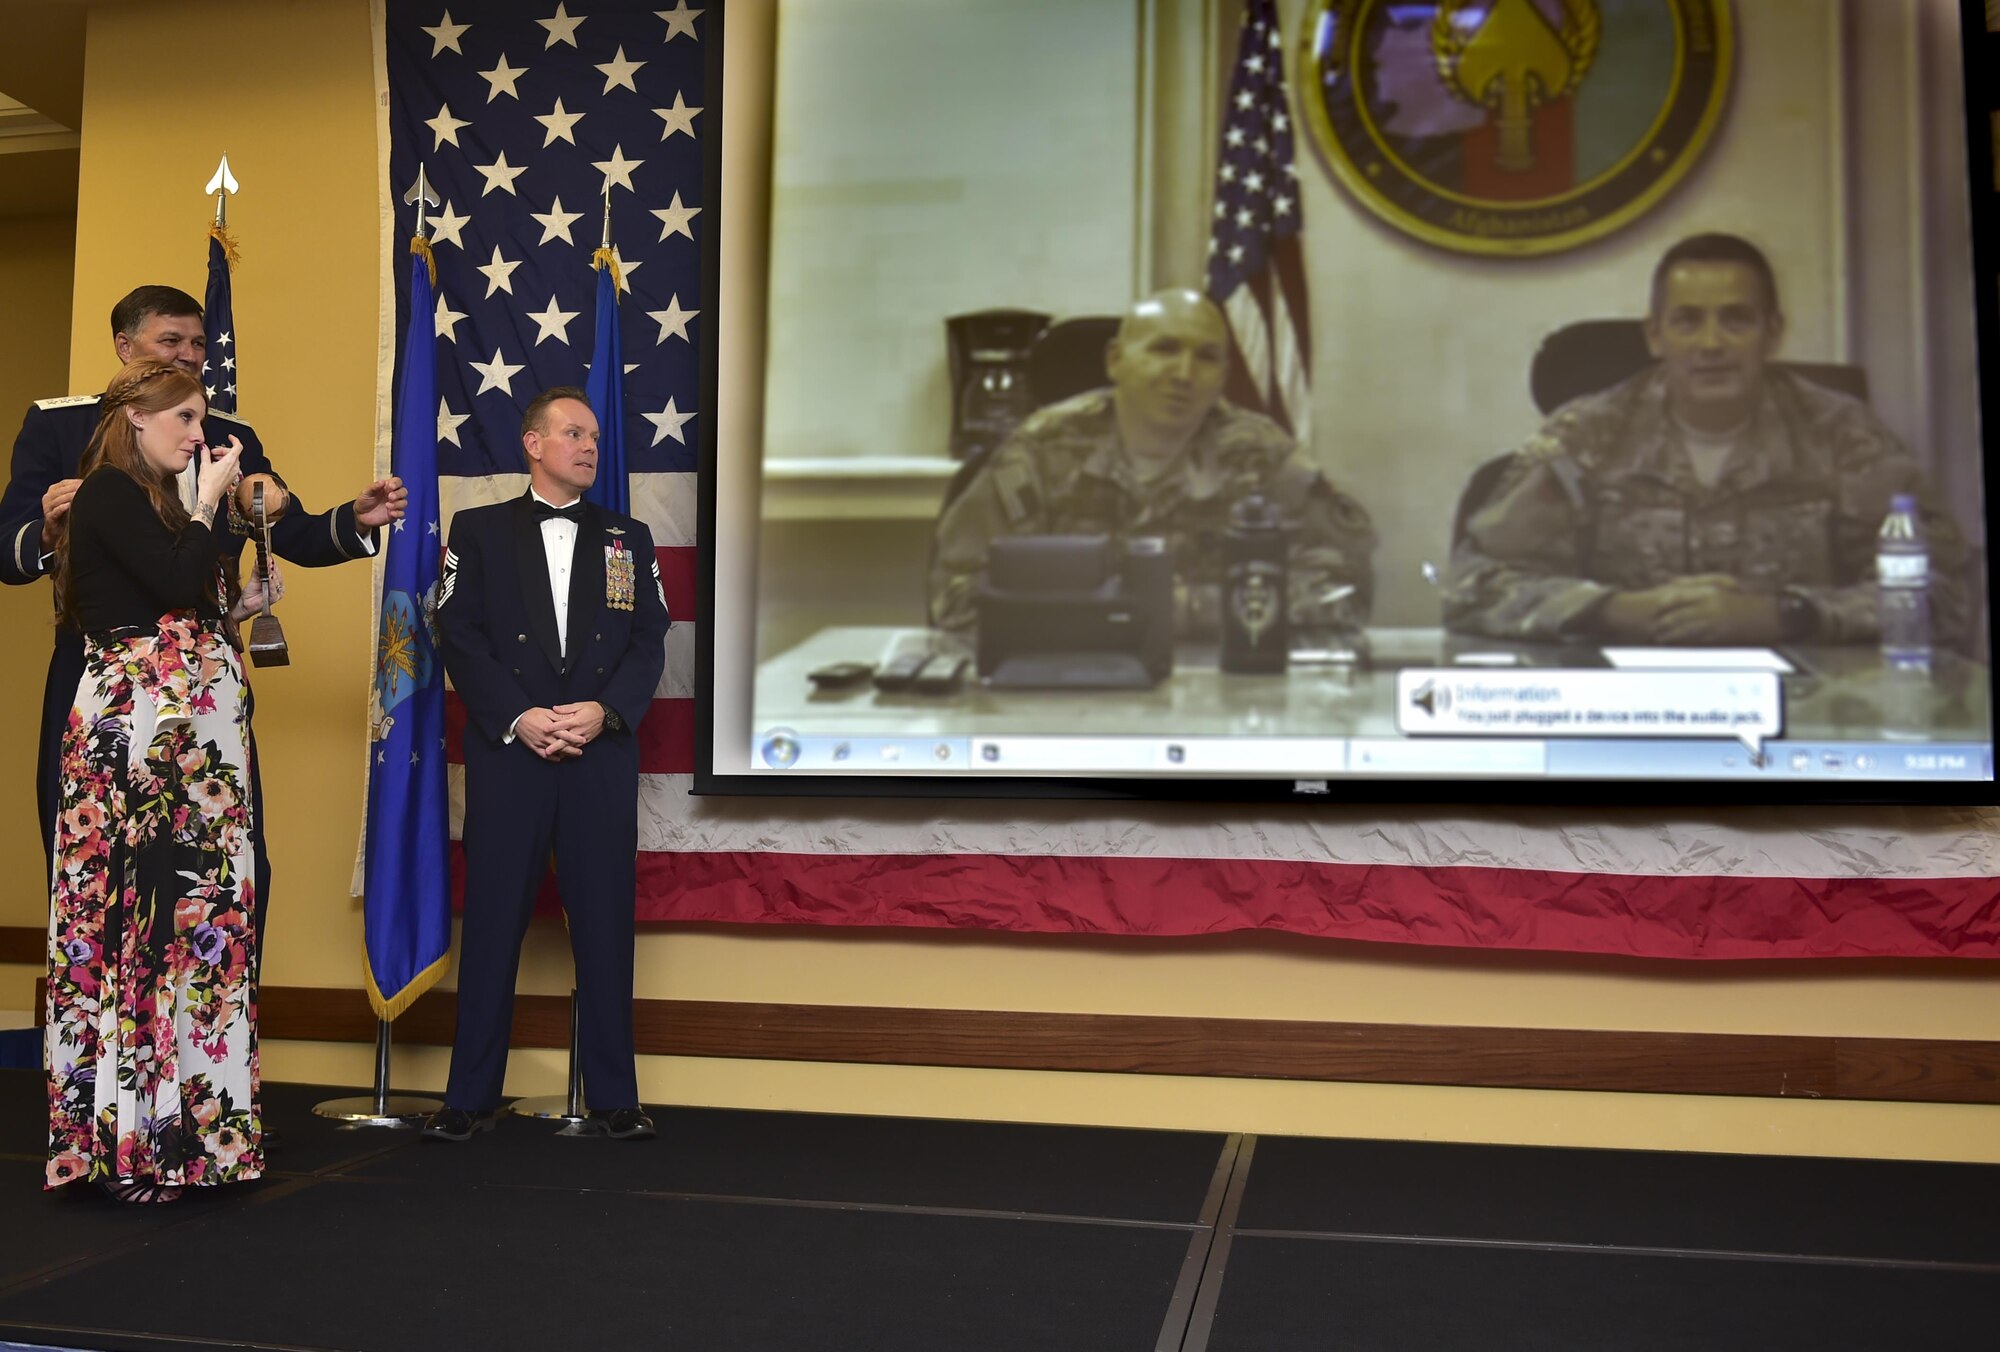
left=1444, top=370, right=1968, bottom=646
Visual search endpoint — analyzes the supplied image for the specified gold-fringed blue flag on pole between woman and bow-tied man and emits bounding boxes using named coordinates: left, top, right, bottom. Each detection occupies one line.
left=362, top=236, right=452, bottom=1018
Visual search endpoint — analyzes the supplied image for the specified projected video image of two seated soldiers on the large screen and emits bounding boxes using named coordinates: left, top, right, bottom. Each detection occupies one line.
left=712, top=0, right=1994, bottom=798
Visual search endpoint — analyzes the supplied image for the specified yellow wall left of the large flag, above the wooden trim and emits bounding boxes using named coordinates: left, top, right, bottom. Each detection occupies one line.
left=0, top=0, right=378, bottom=1008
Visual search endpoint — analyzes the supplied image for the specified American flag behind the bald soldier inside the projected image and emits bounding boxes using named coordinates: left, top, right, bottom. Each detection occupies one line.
left=1208, top=0, right=1312, bottom=444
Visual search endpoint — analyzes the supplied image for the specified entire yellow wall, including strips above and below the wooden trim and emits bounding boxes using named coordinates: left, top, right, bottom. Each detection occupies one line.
left=0, top=0, right=2000, bottom=1160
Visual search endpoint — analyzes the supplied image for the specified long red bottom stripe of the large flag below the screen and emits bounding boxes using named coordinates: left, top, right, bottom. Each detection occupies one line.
left=638, top=850, right=2000, bottom=958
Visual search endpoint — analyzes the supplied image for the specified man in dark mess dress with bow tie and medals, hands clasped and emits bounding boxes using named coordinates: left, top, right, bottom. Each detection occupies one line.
left=424, top=386, right=668, bottom=1140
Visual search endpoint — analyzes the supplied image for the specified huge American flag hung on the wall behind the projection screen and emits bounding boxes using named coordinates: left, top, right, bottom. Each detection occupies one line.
left=380, top=0, right=2000, bottom=958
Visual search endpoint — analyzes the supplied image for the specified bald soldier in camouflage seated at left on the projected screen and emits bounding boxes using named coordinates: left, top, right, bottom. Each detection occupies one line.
left=930, top=290, right=1374, bottom=642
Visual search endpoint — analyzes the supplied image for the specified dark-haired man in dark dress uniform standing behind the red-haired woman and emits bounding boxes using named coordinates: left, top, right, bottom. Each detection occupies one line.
left=0, top=286, right=408, bottom=928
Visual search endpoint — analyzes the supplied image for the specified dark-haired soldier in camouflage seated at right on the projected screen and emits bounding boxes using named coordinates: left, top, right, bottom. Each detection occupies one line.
left=1444, top=234, right=1966, bottom=644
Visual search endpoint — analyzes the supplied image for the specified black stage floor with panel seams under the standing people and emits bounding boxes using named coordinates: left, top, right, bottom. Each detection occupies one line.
left=0, top=1070, right=2000, bottom=1352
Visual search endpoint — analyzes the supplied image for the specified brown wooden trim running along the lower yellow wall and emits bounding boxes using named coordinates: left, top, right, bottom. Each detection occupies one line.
left=0, top=926, right=2000, bottom=1104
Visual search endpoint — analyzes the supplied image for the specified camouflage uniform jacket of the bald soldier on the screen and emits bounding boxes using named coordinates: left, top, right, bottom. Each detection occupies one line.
left=930, top=390, right=1376, bottom=642
